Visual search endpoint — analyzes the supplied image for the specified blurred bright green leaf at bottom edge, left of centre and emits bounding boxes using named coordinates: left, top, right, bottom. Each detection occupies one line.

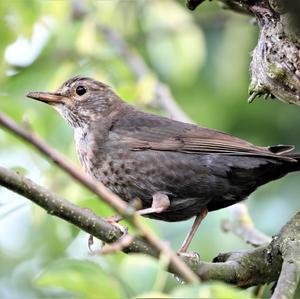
left=35, top=259, right=121, bottom=298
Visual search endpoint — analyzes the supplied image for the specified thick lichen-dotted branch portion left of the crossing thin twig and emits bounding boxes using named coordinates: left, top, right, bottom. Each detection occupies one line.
left=0, top=166, right=155, bottom=257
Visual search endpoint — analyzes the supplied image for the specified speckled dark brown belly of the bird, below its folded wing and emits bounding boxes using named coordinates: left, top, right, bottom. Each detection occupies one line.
left=79, top=150, right=251, bottom=221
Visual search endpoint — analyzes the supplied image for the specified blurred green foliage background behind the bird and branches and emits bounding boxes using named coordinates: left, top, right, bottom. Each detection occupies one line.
left=0, top=0, right=300, bottom=298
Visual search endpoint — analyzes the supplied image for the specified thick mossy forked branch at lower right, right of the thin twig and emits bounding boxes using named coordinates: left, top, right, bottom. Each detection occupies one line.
left=196, top=213, right=300, bottom=290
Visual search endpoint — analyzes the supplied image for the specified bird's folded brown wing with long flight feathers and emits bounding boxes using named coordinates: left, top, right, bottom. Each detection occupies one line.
left=115, top=113, right=294, bottom=159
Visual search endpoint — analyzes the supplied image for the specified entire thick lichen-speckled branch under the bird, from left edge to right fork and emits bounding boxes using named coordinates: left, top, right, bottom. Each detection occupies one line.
left=0, top=167, right=300, bottom=290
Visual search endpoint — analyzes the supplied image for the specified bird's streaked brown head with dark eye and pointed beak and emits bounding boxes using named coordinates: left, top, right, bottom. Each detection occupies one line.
left=27, top=76, right=122, bottom=128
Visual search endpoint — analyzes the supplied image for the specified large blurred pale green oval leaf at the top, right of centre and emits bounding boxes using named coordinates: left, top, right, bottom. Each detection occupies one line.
left=144, top=1, right=206, bottom=86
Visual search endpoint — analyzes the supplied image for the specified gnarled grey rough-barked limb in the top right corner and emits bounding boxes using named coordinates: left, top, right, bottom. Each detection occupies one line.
left=187, top=0, right=300, bottom=105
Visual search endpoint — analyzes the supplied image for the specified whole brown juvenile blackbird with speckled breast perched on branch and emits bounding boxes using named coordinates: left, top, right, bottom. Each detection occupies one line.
left=27, top=77, right=300, bottom=252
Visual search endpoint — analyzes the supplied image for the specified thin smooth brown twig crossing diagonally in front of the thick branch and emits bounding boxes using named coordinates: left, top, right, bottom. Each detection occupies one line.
left=0, top=113, right=199, bottom=283
